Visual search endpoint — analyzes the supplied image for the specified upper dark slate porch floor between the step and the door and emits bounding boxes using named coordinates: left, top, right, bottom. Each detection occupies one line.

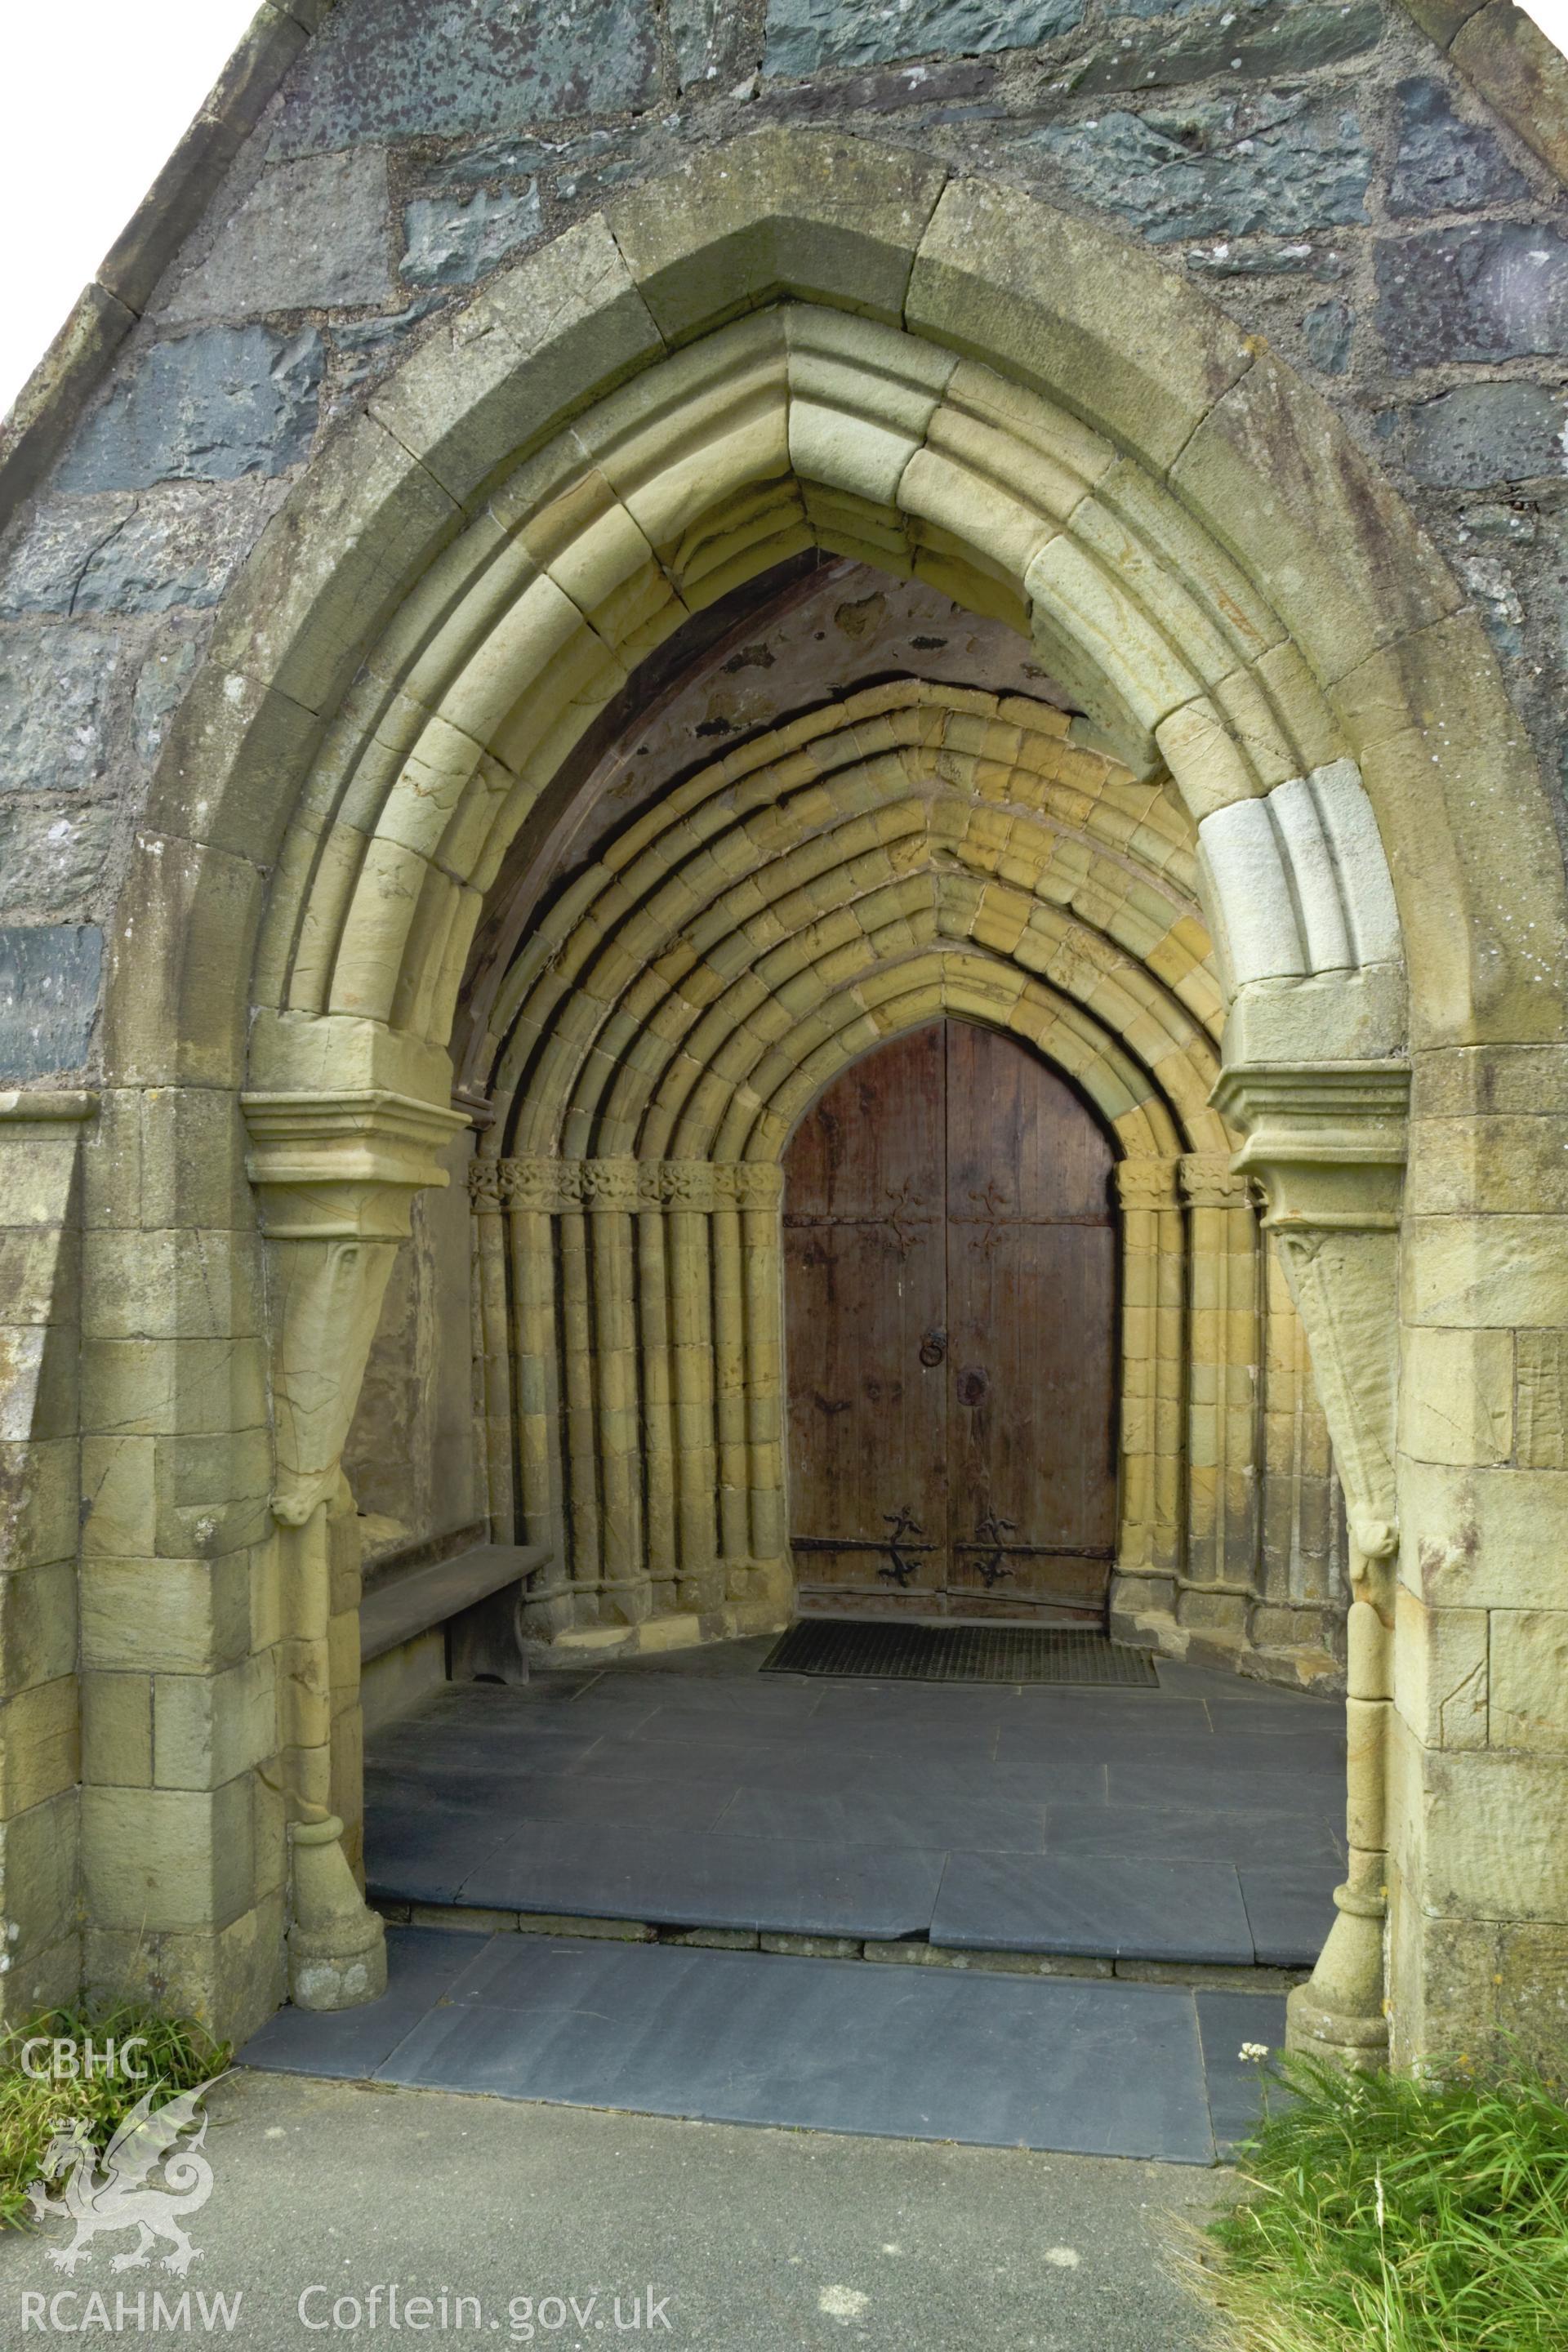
left=364, top=1639, right=1345, bottom=1969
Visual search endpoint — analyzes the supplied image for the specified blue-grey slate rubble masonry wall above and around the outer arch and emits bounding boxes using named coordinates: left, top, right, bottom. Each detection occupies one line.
left=0, top=0, right=1568, bottom=1082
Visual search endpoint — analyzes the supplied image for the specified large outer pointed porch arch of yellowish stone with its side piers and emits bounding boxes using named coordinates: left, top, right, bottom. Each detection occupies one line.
left=5, top=131, right=1568, bottom=2088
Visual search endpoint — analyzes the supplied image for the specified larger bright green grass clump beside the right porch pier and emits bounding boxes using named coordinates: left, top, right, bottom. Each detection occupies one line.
left=1180, top=2056, right=1568, bottom=2352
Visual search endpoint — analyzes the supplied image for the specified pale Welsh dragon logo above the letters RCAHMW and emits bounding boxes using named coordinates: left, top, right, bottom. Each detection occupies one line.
left=29, top=2074, right=219, bottom=2277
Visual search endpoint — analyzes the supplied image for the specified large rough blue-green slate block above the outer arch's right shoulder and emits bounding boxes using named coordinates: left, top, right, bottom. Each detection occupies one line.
left=1025, top=91, right=1373, bottom=245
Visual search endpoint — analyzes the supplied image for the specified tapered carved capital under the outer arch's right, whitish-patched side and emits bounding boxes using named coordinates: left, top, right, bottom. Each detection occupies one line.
left=1213, top=1061, right=1410, bottom=1559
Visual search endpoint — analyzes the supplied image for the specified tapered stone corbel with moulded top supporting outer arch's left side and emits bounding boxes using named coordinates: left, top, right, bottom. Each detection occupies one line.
left=242, top=1089, right=468, bottom=1526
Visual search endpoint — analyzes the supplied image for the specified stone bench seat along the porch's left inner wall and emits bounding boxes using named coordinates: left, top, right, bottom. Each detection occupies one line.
left=359, top=1543, right=550, bottom=1731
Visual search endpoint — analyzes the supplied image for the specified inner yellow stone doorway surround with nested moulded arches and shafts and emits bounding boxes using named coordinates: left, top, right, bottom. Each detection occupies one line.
left=466, top=677, right=1359, bottom=1682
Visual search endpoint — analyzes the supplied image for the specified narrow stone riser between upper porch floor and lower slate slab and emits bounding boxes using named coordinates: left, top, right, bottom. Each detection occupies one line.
left=374, top=1900, right=1312, bottom=1994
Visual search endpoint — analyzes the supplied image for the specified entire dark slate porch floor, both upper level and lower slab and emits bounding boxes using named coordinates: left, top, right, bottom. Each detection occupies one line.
left=242, top=1642, right=1345, bottom=2164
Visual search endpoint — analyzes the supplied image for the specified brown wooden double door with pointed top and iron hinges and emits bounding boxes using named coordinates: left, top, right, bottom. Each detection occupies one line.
left=785, top=1021, right=1116, bottom=1625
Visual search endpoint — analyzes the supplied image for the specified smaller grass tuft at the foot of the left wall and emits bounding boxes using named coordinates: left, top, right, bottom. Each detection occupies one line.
left=0, top=2002, right=230, bottom=2230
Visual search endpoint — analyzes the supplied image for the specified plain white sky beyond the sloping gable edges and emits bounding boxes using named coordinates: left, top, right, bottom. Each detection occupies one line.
left=0, top=0, right=1568, bottom=414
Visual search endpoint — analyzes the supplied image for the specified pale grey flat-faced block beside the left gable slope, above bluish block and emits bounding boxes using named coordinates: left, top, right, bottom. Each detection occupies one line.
left=163, top=148, right=393, bottom=324
